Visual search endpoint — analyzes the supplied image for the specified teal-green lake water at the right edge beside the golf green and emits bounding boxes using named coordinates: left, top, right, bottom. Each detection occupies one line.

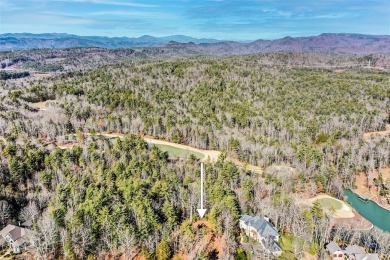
left=344, top=190, right=390, bottom=232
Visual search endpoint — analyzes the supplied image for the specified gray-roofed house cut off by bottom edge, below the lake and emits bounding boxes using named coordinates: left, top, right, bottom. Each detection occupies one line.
left=326, top=242, right=379, bottom=260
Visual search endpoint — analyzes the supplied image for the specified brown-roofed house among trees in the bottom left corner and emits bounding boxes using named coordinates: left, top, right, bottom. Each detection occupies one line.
left=0, top=225, right=29, bottom=253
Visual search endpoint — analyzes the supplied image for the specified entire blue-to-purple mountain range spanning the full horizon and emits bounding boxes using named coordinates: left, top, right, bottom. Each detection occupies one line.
left=0, top=33, right=390, bottom=55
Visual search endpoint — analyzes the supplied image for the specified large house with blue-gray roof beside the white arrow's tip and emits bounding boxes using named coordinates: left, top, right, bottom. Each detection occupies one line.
left=239, top=215, right=282, bottom=256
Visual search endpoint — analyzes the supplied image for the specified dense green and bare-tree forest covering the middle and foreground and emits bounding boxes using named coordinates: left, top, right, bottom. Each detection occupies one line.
left=0, top=53, right=390, bottom=259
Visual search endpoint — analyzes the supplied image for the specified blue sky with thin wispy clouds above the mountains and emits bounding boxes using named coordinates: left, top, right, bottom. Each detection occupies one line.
left=0, top=0, right=390, bottom=40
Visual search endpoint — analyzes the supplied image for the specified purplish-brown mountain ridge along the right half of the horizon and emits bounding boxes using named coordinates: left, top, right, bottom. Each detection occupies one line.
left=168, top=33, right=390, bottom=55
